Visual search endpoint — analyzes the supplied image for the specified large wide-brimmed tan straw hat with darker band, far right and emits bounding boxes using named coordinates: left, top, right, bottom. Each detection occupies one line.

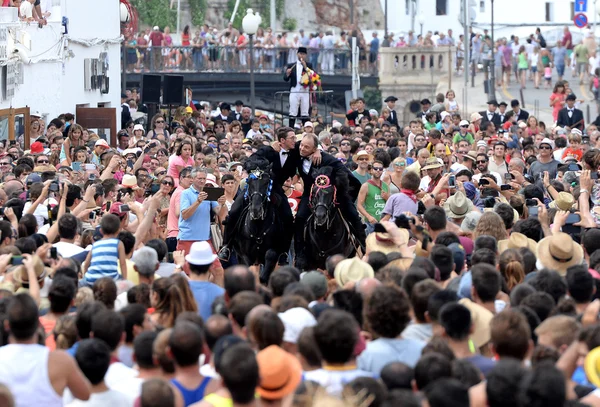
left=537, top=232, right=583, bottom=276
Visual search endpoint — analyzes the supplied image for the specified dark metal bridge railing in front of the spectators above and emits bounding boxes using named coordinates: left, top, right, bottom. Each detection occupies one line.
left=122, top=45, right=378, bottom=76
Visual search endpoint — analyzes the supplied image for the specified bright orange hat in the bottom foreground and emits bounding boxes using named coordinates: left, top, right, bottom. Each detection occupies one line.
left=256, top=345, right=302, bottom=400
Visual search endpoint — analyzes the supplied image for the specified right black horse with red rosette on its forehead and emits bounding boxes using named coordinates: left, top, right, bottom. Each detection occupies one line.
left=304, top=167, right=356, bottom=270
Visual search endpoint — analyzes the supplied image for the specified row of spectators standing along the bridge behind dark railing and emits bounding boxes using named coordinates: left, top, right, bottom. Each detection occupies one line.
left=125, top=23, right=380, bottom=75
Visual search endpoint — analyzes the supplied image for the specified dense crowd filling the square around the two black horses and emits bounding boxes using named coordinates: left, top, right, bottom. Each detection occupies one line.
left=7, top=43, right=600, bottom=407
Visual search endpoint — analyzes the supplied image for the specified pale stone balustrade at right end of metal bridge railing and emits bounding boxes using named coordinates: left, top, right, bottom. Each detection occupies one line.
left=379, top=47, right=456, bottom=82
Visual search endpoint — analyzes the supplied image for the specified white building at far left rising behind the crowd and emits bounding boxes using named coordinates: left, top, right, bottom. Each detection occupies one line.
left=0, top=0, right=121, bottom=147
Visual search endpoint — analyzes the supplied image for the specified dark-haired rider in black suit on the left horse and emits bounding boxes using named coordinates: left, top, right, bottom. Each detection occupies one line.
left=219, top=127, right=300, bottom=261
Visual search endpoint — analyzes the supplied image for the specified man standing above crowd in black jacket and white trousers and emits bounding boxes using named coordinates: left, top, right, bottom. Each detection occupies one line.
left=283, top=47, right=313, bottom=128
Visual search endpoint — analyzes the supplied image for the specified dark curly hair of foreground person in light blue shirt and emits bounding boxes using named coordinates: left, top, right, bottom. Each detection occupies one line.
left=365, top=286, right=410, bottom=338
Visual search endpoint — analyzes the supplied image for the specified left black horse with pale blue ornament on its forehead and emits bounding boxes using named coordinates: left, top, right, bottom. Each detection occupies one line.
left=228, top=158, right=289, bottom=284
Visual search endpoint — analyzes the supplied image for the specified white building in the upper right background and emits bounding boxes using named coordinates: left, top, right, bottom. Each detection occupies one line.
left=380, top=0, right=600, bottom=39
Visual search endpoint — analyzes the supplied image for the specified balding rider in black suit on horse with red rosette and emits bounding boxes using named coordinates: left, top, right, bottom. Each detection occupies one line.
left=294, top=135, right=366, bottom=267
